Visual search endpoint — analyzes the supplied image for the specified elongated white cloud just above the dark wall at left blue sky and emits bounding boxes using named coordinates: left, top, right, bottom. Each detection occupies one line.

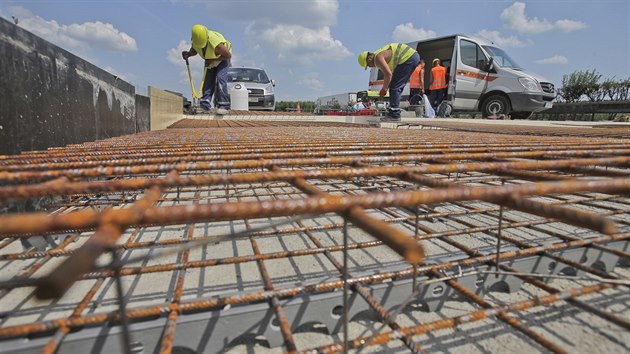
left=9, top=6, right=138, bottom=52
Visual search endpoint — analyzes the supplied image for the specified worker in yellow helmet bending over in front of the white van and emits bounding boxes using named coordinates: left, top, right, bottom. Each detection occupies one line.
left=358, top=43, right=420, bottom=122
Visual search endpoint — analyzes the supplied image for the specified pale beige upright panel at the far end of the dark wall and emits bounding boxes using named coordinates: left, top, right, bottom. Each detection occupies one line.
left=149, top=86, right=184, bottom=130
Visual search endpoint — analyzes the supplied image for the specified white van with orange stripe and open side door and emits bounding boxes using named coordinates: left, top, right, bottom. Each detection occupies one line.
left=369, top=34, right=556, bottom=119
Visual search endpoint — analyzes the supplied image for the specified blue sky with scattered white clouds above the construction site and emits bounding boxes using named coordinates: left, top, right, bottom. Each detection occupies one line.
left=0, top=0, right=630, bottom=100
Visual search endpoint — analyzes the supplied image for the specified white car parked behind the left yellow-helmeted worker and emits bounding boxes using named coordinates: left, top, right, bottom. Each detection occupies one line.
left=228, top=67, right=276, bottom=111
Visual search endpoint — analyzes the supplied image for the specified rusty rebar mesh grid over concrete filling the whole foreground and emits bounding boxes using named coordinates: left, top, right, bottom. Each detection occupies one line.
left=0, top=124, right=630, bottom=353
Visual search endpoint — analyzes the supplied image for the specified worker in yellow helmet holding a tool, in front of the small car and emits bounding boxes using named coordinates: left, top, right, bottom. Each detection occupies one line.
left=182, top=25, right=232, bottom=114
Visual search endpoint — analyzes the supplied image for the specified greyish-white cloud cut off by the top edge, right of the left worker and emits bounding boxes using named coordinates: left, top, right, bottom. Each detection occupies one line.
left=199, top=0, right=339, bottom=28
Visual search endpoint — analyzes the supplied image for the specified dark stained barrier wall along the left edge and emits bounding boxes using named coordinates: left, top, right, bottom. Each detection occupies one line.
left=0, top=18, right=147, bottom=155
